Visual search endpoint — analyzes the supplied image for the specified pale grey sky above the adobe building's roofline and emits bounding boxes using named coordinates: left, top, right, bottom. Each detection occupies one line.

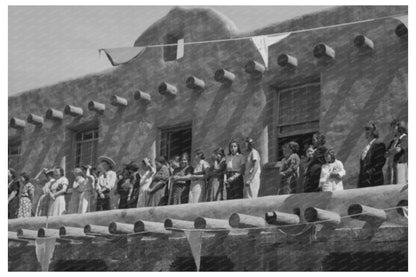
left=8, top=6, right=330, bottom=96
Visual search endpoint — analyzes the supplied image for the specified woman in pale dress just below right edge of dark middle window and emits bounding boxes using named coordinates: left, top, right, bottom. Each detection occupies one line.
left=189, top=149, right=210, bottom=203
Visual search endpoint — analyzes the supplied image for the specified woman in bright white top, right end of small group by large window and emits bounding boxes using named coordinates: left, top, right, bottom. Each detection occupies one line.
left=319, top=149, right=345, bottom=191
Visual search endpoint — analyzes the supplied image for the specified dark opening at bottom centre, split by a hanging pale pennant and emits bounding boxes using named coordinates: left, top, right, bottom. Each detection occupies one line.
left=170, top=256, right=234, bottom=271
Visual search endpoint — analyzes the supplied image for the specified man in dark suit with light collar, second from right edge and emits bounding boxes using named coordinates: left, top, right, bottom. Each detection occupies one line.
left=357, top=123, right=386, bottom=188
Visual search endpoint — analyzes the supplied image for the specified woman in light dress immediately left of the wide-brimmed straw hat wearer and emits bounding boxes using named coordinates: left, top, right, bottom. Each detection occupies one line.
left=78, top=165, right=95, bottom=214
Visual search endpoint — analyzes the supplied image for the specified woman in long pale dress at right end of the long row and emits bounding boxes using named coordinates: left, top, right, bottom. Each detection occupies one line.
left=243, top=137, right=261, bottom=198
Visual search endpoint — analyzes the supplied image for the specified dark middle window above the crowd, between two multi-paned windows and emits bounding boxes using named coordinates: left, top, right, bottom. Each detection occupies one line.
left=160, top=124, right=192, bottom=159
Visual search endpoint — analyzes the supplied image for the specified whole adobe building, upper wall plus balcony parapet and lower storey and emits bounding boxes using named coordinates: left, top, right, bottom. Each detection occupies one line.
left=8, top=6, right=408, bottom=271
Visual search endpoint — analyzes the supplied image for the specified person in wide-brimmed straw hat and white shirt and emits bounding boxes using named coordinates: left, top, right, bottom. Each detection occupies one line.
left=96, top=156, right=117, bottom=211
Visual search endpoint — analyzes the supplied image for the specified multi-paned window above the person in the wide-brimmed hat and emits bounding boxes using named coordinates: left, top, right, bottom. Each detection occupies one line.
left=75, top=129, right=98, bottom=167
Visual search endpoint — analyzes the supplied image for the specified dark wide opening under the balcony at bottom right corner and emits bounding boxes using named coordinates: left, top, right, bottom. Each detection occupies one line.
left=322, top=251, right=408, bottom=271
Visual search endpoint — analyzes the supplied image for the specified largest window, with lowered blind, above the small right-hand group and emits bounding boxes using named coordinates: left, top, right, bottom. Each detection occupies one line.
left=277, top=82, right=321, bottom=160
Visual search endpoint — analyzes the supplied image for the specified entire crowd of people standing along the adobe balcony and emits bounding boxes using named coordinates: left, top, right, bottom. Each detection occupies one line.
left=8, top=120, right=407, bottom=218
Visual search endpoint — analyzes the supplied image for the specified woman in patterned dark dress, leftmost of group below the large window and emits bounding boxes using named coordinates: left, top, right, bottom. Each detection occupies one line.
left=277, top=141, right=300, bottom=194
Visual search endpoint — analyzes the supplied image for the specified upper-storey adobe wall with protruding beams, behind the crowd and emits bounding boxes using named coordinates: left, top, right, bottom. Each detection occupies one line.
left=9, top=6, right=408, bottom=199
